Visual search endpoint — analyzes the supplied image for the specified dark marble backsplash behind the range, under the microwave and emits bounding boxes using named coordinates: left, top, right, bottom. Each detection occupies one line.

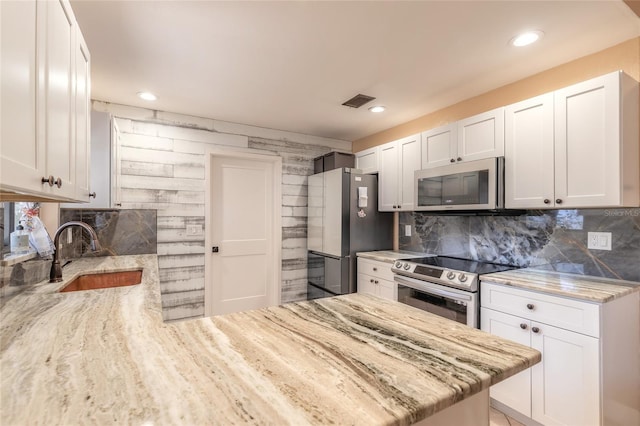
left=399, top=208, right=640, bottom=281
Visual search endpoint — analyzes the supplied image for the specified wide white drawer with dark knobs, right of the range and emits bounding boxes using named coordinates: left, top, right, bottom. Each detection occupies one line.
left=480, top=281, right=600, bottom=337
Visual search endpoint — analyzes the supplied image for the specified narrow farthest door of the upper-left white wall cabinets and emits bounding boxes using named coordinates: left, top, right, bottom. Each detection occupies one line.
left=74, top=26, right=92, bottom=202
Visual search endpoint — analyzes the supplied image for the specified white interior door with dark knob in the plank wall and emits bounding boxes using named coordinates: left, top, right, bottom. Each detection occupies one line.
left=206, top=155, right=281, bottom=315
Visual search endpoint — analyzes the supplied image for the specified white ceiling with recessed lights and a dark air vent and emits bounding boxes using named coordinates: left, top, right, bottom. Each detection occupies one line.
left=71, top=0, right=640, bottom=140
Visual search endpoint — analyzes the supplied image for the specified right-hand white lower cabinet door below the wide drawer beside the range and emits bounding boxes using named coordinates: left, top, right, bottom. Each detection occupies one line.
left=531, top=322, right=600, bottom=426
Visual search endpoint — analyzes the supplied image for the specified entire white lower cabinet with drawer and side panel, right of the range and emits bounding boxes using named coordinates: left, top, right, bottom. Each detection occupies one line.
left=480, top=282, right=640, bottom=426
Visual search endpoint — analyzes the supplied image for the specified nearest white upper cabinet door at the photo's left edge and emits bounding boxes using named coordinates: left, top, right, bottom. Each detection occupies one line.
left=0, top=1, right=46, bottom=193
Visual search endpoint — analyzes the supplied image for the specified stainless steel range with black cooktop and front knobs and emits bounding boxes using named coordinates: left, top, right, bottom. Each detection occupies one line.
left=391, top=256, right=516, bottom=328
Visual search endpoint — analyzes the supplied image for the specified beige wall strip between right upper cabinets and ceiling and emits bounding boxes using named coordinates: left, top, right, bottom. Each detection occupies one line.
left=353, top=37, right=640, bottom=152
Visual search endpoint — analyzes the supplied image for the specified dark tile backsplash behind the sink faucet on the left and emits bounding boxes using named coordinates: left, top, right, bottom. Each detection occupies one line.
left=60, top=209, right=158, bottom=259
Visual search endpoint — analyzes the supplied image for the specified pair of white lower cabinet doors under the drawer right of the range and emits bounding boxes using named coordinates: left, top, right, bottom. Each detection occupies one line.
left=480, top=308, right=600, bottom=425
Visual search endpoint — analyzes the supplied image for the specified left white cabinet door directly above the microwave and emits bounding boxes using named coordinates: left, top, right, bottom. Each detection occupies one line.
left=420, top=123, right=458, bottom=169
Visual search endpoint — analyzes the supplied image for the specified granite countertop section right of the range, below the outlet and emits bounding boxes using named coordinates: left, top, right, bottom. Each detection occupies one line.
left=480, top=267, right=640, bottom=303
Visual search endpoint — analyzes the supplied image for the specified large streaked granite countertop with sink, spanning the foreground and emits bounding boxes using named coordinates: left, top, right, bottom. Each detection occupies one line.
left=0, top=255, right=540, bottom=425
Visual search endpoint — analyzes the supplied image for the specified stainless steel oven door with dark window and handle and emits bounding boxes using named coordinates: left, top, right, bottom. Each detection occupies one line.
left=394, top=275, right=479, bottom=328
